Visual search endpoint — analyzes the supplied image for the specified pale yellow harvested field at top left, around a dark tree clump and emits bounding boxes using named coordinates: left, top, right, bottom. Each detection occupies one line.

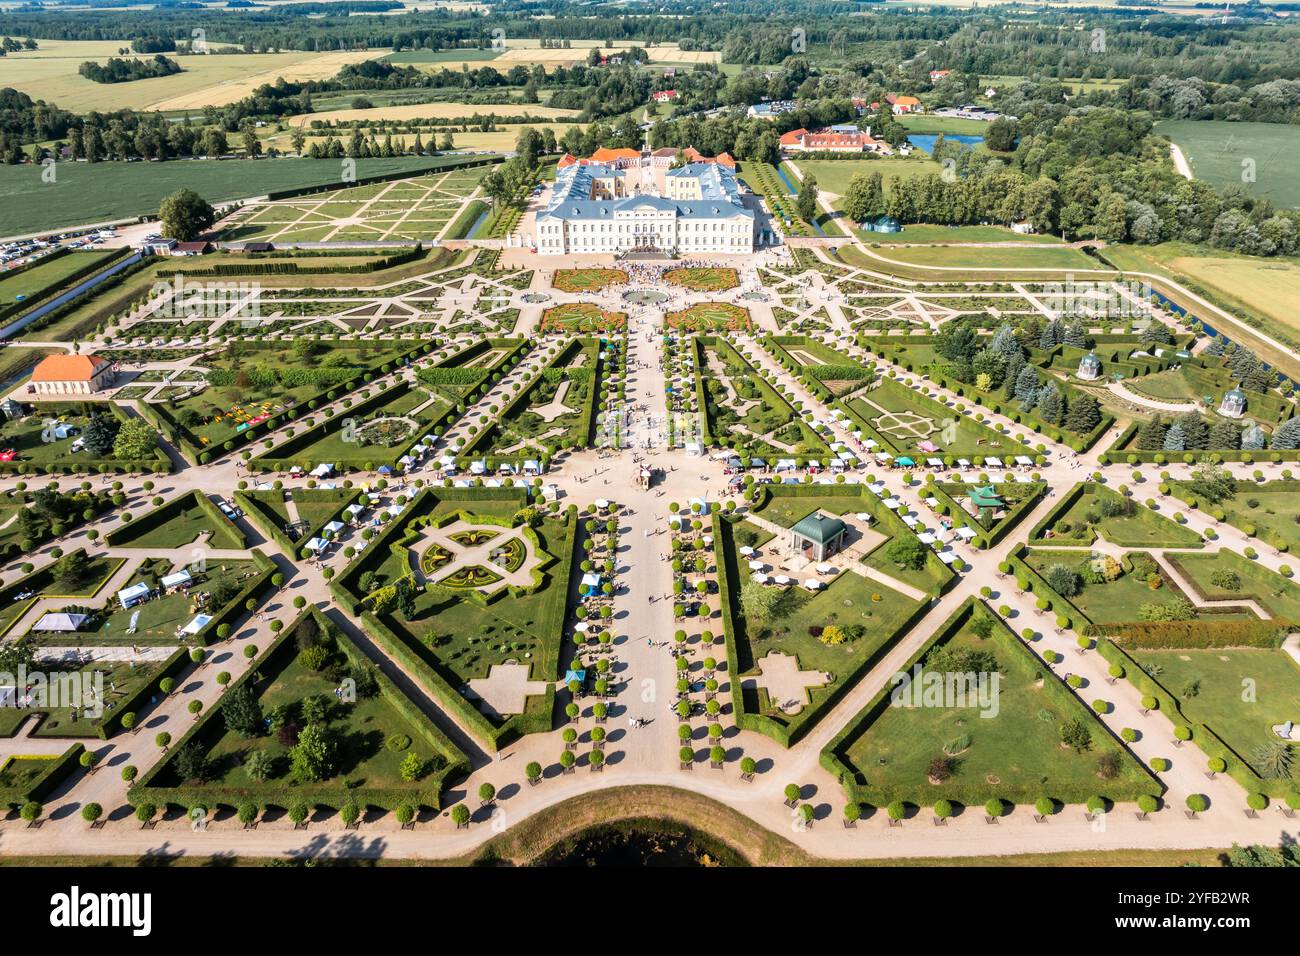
left=4, top=40, right=382, bottom=112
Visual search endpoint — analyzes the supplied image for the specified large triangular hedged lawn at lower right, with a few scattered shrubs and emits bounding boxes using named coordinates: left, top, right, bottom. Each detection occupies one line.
left=845, top=608, right=1154, bottom=806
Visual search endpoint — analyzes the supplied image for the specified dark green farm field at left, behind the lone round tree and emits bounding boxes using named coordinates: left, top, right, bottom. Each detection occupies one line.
left=0, top=156, right=478, bottom=235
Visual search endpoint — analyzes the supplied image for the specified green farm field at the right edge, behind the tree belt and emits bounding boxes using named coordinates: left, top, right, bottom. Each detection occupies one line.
left=1156, top=120, right=1300, bottom=208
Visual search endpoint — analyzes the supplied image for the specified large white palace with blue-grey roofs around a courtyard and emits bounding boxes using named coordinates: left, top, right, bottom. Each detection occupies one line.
left=534, top=141, right=755, bottom=256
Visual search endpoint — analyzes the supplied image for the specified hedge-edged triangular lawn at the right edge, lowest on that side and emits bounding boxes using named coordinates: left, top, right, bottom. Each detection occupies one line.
left=1134, top=648, right=1300, bottom=771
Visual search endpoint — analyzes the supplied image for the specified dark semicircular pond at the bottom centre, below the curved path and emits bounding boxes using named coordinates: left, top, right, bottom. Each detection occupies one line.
left=533, top=819, right=748, bottom=868
